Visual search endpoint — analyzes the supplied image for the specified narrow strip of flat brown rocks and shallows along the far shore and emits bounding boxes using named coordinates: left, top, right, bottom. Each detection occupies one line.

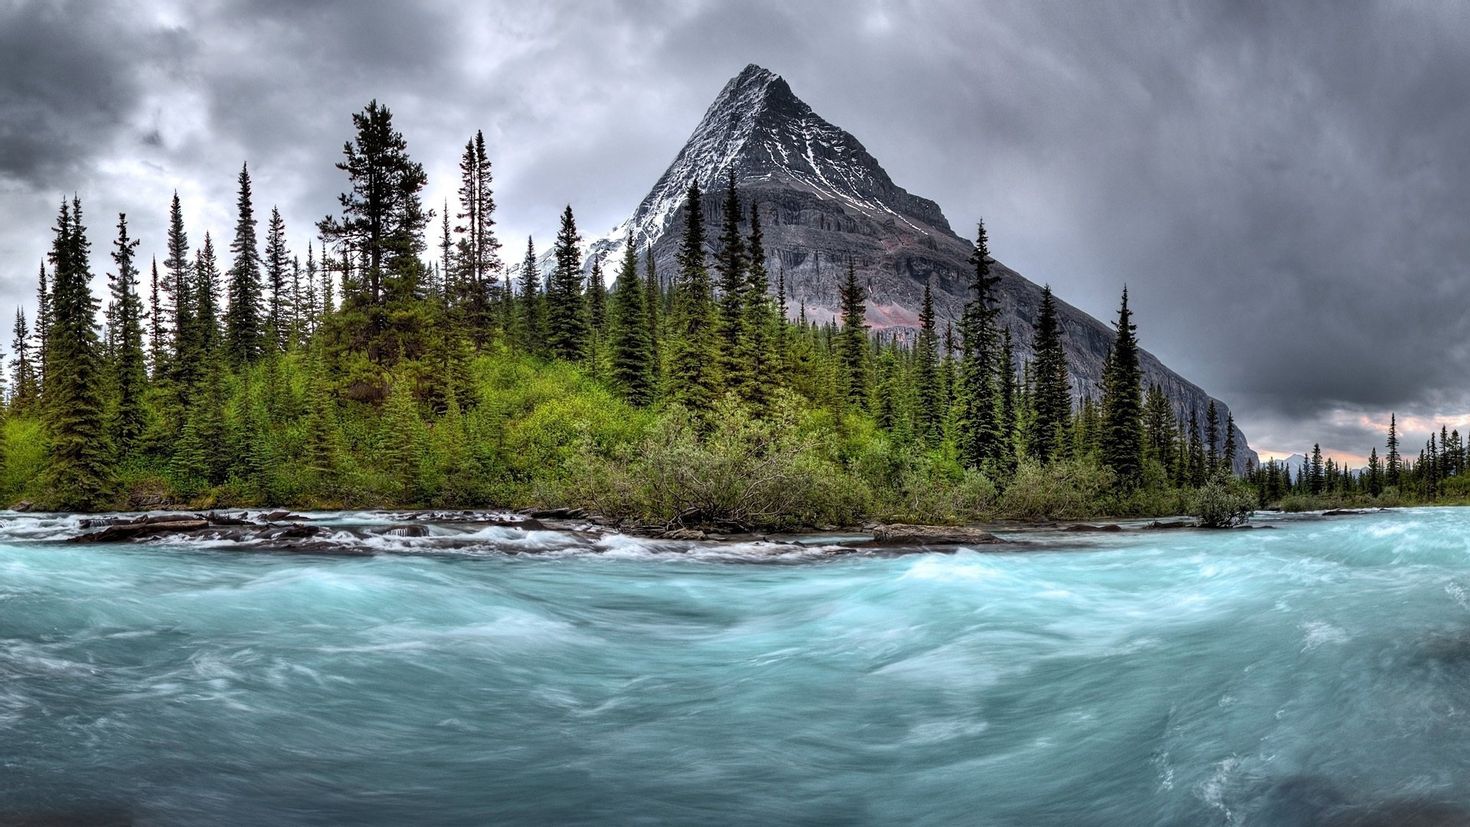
left=22, top=508, right=1370, bottom=557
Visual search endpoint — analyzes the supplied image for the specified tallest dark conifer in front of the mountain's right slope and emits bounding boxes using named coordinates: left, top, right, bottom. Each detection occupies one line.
left=958, top=222, right=1001, bottom=469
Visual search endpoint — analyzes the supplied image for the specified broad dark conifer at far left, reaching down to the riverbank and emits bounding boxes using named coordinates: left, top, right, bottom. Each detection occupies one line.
left=46, top=198, right=113, bottom=511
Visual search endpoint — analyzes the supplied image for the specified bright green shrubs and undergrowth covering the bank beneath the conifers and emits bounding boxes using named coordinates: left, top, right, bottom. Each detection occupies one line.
left=0, top=353, right=1252, bottom=529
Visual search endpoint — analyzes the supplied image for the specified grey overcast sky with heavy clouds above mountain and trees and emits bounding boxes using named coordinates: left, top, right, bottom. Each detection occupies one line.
left=0, top=0, right=1470, bottom=455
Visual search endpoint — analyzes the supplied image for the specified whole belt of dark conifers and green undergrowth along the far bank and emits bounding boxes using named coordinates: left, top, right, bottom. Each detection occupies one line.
left=0, top=101, right=1440, bottom=527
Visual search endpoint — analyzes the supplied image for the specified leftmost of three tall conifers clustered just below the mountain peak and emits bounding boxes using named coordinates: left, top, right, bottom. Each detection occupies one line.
left=669, top=184, right=719, bottom=411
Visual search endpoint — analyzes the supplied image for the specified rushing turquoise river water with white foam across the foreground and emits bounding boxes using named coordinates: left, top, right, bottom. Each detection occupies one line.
left=0, top=508, right=1470, bottom=824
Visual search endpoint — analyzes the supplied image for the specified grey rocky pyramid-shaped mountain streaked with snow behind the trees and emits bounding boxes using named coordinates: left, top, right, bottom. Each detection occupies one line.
left=573, top=65, right=1255, bottom=470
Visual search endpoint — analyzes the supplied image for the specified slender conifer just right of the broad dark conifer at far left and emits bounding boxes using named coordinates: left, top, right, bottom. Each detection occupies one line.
left=110, top=213, right=148, bottom=455
